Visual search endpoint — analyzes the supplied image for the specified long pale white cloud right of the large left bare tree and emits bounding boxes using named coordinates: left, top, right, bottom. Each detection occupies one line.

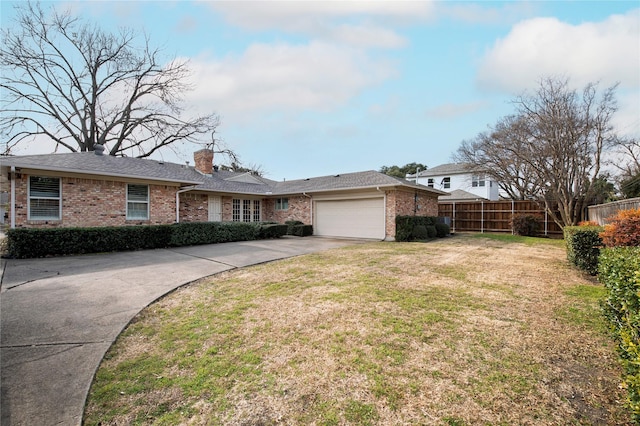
left=181, top=42, right=395, bottom=117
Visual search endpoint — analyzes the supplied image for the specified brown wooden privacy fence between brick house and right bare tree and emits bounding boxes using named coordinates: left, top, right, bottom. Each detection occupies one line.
left=438, top=201, right=562, bottom=236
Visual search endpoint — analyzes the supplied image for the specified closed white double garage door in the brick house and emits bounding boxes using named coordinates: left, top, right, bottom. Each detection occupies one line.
left=313, top=198, right=385, bottom=240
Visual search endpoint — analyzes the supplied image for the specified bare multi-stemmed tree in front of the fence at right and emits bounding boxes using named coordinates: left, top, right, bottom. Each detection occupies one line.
left=457, top=78, right=617, bottom=226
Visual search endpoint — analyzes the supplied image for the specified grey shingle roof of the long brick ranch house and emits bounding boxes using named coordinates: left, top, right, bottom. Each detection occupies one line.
left=0, top=152, right=445, bottom=195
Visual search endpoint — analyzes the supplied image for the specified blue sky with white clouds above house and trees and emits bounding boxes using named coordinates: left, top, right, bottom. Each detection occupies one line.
left=1, top=0, right=640, bottom=180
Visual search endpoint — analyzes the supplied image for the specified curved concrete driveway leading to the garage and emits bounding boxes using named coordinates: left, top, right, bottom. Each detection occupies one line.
left=0, top=237, right=356, bottom=426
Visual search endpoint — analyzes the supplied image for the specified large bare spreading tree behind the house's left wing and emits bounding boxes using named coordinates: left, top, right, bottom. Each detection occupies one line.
left=0, top=3, right=219, bottom=157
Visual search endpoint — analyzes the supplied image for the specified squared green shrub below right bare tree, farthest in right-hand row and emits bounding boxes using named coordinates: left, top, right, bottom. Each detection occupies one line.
left=564, top=226, right=604, bottom=275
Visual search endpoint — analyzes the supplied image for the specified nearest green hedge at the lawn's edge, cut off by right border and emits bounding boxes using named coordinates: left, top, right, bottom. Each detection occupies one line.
left=598, top=247, right=640, bottom=424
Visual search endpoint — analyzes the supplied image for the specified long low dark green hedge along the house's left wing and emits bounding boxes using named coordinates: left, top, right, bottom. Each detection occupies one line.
left=7, top=222, right=280, bottom=258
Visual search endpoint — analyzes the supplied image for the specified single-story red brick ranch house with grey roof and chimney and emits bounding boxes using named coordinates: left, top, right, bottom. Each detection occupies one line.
left=0, top=149, right=444, bottom=240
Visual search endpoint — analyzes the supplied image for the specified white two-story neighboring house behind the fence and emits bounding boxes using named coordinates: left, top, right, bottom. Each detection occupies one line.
left=405, top=163, right=500, bottom=201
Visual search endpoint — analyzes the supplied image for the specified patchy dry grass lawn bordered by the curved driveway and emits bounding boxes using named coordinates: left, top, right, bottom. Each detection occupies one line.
left=85, top=235, right=630, bottom=425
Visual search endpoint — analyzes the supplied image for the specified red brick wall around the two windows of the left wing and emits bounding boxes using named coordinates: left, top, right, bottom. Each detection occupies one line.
left=10, top=174, right=177, bottom=228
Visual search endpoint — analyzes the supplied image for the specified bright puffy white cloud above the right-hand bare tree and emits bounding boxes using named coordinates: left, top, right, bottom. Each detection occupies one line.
left=477, top=9, right=640, bottom=93
